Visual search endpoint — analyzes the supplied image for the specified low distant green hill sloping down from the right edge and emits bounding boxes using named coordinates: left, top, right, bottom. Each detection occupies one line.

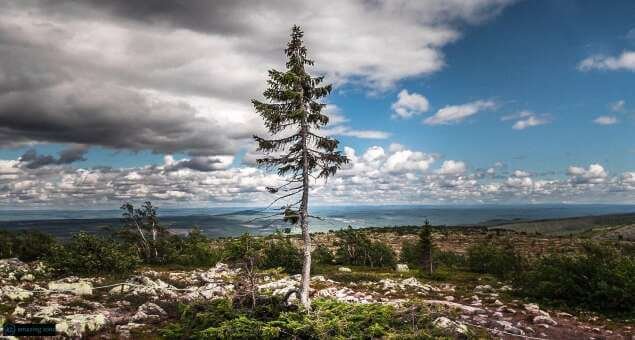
left=487, top=214, right=635, bottom=241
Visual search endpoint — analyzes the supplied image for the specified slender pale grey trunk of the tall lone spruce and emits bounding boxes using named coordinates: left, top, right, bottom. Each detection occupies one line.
left=300, top=112, right=311, bottom=310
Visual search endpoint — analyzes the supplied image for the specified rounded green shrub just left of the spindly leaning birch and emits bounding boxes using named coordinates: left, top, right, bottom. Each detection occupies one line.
left=45, top=232, right=141, bottom=276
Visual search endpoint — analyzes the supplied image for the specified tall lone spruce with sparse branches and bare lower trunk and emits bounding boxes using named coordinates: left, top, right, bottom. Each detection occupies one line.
left=252, top=26, right=348, bottom=310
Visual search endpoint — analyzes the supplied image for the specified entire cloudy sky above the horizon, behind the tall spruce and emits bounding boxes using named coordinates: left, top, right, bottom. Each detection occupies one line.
left=0, top=0, right=635, bottom=209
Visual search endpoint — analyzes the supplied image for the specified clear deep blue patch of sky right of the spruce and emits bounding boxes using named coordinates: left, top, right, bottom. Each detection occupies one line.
left=331, top=1, right=635, bottom=175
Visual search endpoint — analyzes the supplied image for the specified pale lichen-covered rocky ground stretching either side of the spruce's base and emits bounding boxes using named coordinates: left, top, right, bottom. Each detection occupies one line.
left=0, top=259, right=635, bottom=339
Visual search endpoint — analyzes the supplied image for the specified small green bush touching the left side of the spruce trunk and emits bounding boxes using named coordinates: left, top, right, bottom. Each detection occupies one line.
left=260, top=234, right=302, bottom=274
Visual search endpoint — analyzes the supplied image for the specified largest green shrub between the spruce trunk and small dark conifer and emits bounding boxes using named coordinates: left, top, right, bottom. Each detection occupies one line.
left=335, top=226, right=396, bottom=267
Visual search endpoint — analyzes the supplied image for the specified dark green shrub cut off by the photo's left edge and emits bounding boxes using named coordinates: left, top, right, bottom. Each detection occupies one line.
left=0, top=230, right=58, bottom=261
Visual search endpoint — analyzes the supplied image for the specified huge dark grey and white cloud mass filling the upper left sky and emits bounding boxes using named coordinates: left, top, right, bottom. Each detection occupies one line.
left=0, top=0, right=511, bottom=157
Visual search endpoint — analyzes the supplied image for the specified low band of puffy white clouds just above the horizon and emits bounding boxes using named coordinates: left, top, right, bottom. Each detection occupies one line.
left=0, top=150, right=635, bottom=208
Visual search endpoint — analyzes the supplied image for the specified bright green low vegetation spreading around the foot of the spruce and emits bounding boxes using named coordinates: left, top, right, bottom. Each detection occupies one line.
left=160, top=299, right=453, bottom=339
